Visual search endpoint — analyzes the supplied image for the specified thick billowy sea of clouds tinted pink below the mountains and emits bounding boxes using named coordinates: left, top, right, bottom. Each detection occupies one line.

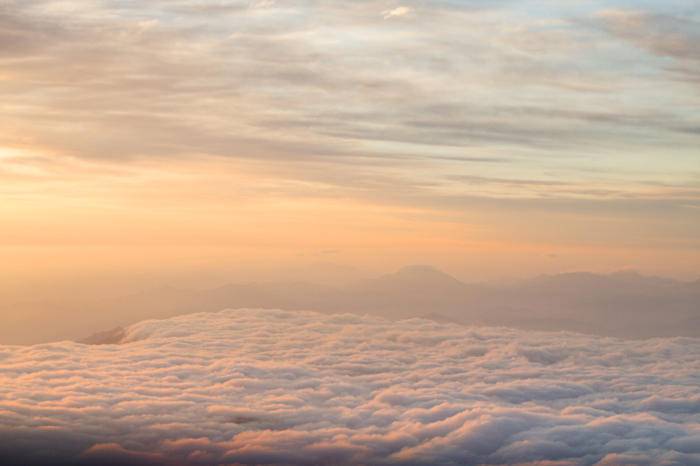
left=0, top=309, right=700, bottom=466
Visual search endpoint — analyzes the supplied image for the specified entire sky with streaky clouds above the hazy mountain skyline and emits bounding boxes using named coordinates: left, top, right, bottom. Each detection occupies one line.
left=0, top=0, right=700, bottom=286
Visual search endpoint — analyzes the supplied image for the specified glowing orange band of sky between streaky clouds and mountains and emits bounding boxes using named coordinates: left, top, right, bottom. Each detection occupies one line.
left=0, top=154, right=699, bottom=286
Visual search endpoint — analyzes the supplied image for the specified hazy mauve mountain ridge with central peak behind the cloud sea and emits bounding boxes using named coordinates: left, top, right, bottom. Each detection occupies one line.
left=76, top=265, right=700, bottom=338
